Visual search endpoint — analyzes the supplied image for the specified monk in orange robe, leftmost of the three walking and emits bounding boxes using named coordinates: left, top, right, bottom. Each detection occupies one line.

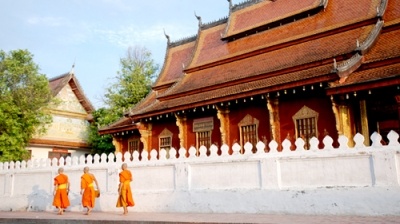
left=53, top=167, right=70, bottom=215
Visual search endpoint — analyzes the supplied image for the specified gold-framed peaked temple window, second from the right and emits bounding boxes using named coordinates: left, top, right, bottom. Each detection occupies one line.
left=239, top=114, right=259, bottom=153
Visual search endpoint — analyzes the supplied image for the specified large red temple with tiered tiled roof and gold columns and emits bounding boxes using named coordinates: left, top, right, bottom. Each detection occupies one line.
left=99, top=0, right=400, bottom=158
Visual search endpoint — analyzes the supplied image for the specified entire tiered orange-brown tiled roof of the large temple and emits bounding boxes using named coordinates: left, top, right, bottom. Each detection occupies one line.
left=95, top=0, right=400, bottom=130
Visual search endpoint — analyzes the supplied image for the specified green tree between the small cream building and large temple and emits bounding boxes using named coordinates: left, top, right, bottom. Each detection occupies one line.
left=89, top=47, right=158, bottom=154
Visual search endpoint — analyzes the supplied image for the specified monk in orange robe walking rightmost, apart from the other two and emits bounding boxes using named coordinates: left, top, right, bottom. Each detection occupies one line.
left=117, top=163, right=135, bottom=215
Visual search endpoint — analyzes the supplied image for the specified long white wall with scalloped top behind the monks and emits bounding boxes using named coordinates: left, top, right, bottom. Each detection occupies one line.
left=0, top=132, right=400, bottom=215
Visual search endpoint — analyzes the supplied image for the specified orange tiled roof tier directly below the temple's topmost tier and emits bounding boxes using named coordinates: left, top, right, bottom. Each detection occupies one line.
left=188, top=0, right=381, bottom=69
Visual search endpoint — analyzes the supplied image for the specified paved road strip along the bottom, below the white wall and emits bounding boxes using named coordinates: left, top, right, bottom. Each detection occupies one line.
left=0, top=212, right=400, bottom=224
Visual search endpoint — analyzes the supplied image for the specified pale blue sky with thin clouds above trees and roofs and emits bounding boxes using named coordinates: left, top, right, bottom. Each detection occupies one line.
left=0, top=0, right=230, bottom=109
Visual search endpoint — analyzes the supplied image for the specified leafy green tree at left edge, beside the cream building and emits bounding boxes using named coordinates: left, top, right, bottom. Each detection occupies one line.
left=0, top=50, right=53, bottom=161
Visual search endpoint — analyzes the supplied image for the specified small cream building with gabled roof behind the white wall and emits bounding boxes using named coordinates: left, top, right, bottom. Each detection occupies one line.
left=27, top=70, right=94, bottom=159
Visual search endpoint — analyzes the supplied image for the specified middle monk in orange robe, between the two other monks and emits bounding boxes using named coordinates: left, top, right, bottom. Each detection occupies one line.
left=81, top=166, right=100, bottom=215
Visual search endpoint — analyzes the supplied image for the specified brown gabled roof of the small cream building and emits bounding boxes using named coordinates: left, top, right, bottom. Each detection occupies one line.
left=49, top=70, right=95, bottom=114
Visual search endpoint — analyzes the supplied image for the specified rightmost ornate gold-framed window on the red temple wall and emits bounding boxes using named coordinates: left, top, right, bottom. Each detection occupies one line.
left=293, top=106, right=318, bottom=149
